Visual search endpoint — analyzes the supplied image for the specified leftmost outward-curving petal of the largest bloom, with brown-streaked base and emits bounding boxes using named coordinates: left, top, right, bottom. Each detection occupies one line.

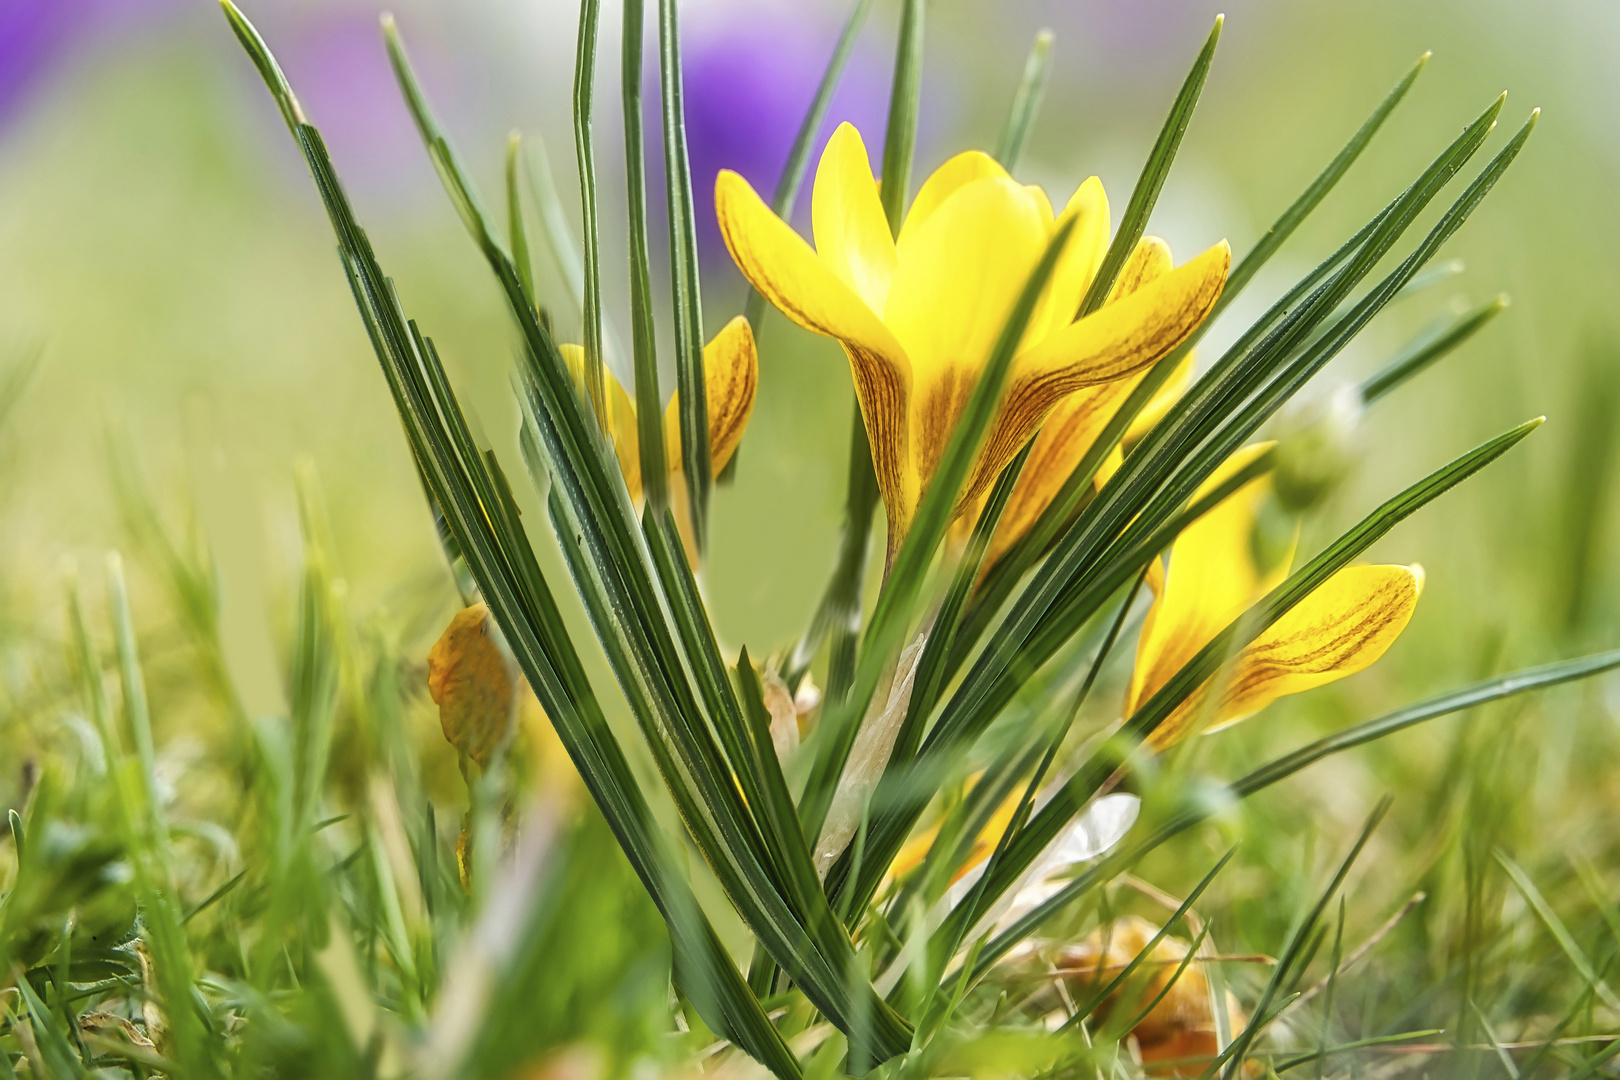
left=714, top=170, right=917, bottom=536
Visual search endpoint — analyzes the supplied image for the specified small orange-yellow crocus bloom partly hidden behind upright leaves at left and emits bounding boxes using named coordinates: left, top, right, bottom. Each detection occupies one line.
left=559, top=316, right=760, bottom=498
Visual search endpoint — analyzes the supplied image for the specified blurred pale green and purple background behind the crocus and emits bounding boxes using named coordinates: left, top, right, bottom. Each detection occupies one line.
left=0, top=0, right=1620, bottom=1016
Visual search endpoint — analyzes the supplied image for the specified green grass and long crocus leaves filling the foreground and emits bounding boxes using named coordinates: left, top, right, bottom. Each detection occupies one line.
left=0, top=0, right=1620, bottom=1080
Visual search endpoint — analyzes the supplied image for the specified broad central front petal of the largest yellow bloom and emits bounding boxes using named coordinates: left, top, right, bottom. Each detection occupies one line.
left=885, top=178, right=1047, bottom=498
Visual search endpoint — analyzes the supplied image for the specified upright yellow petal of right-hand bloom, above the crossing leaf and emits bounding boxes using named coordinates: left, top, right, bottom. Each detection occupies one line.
left=1124, top=444, right=1288, bottom=716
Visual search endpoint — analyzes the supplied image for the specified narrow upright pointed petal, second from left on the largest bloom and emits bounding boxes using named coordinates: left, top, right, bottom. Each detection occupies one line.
left=810, top=123, right=894, bottom=311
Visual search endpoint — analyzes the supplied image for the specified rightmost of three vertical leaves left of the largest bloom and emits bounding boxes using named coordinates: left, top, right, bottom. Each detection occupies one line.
left=658, top=0, right=714, bottom=552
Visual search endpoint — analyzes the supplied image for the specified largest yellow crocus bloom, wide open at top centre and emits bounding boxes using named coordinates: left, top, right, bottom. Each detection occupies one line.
left=714, top=123, right=1231, bottom=557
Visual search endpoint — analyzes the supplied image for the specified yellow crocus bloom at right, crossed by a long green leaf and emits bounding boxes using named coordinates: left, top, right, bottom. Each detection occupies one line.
left=1124, top=445, right=1424, bottom=750
